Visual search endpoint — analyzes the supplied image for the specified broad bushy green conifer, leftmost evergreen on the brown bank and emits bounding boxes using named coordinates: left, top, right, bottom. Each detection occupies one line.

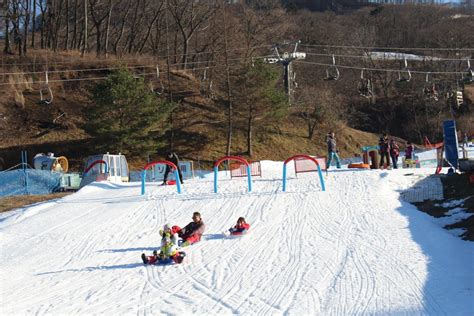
left=85, top=68, right=173, bottom=153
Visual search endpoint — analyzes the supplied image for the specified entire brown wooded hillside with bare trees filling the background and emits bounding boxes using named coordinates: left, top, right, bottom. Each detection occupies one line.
left=0, top=0, right=474, bottom=170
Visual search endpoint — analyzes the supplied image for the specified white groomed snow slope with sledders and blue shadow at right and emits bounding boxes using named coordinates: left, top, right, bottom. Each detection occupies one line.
left=0, top=161, right=474, bottom=315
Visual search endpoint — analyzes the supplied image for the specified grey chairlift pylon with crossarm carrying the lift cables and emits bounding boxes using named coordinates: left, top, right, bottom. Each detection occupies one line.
left=264, top=41, right=306, bottom=105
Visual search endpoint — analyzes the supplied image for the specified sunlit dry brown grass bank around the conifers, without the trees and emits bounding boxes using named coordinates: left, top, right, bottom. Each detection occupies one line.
left=0, top=50, right=378, bottom=170
